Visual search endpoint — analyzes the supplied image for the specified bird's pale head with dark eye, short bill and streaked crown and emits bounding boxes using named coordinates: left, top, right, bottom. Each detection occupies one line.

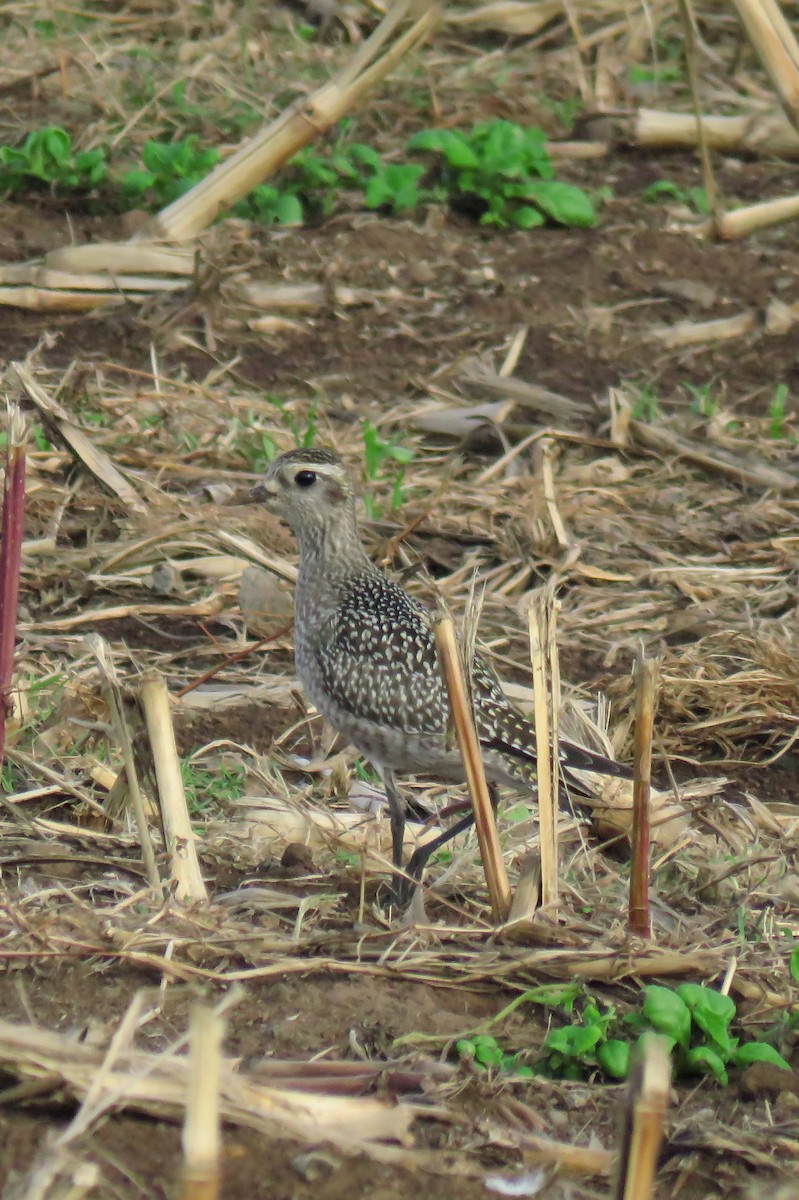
left=250, top=450, right=355, bottom=540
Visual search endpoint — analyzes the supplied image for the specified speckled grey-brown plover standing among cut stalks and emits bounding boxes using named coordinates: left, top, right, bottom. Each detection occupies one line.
left=251, top=449, right=631, bottom=896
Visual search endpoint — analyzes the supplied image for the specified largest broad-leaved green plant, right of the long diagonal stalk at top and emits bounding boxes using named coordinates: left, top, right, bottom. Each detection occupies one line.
left=408, top=120, right=596, bottom=229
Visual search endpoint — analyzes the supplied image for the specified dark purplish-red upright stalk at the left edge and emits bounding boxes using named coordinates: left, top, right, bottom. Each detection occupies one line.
left=0, top=404, right=28, bottom=782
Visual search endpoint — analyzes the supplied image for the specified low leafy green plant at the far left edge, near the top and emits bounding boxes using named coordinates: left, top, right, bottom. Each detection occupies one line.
left=0, top=125, right=108, bottom=193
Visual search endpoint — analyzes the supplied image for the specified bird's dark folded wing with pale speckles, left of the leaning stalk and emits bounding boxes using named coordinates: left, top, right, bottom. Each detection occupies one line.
left=317, top=572, right=449, bottom=734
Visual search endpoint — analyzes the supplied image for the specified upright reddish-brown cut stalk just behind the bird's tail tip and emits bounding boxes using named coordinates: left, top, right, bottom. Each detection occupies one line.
left=629, top=653, right=660, bottom=937
